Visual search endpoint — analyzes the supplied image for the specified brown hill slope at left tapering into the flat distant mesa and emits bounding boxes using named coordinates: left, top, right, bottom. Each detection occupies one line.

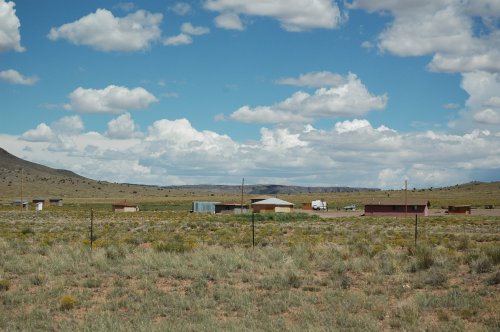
left=0, top=148, right=379, bottom=198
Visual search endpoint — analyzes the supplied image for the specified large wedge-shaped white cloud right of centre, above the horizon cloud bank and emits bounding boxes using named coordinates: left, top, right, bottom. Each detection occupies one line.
left=230, top=73, right=388, bottom=123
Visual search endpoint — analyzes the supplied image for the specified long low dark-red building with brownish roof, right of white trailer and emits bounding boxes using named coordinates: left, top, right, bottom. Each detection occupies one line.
left=364, top=198, right=430, bottom=217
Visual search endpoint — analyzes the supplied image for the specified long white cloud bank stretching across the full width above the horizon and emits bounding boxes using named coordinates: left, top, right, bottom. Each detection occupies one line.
left=5, top=113, right=500, bottom=188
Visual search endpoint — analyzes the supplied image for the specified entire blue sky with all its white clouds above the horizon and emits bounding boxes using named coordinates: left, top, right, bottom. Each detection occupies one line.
left=0, top=0, right=500, bottom=188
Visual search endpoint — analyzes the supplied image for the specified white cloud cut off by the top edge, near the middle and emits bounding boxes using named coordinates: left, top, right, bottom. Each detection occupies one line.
left=204, top=0, right=342, bottom=31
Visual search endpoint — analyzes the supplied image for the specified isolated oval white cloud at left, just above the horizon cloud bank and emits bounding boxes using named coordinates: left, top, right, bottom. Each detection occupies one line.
left=65, top=85, right=158, bottom=113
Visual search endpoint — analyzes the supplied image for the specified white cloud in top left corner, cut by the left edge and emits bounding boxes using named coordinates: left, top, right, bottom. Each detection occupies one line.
left=0, top=0, right=24, bottom=52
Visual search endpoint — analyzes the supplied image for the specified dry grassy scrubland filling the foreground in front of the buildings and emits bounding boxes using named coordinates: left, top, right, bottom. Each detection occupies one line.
left=0, top=208, right=500, bottom=331
